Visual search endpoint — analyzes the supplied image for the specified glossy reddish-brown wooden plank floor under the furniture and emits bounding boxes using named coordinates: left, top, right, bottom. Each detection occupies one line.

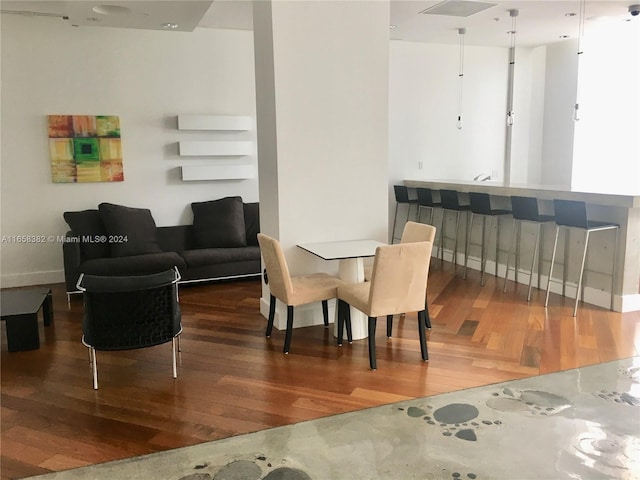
left=1, top=263, right=640, bottom=479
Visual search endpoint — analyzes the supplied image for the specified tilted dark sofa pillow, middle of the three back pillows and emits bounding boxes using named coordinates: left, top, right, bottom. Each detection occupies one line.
left=98, top=203, right=162, bottom=257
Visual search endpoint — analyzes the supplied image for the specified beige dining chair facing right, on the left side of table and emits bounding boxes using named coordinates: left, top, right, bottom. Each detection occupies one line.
left=258, top=233, right=343, bottom=353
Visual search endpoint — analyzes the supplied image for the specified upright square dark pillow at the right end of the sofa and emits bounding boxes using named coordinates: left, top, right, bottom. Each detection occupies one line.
left=191, top=197, right=247, bottom=248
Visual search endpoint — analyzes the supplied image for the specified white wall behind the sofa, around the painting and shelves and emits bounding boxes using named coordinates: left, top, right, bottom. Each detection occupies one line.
left=1, top=15, right=258, bottom=287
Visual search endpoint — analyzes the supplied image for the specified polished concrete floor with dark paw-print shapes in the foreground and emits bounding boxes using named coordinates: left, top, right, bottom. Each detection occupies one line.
left=28, top=357, right=640, bottom=480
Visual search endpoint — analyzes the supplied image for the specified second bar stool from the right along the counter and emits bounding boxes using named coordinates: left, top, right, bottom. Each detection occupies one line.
left=503, top=195, right=555, bottom=302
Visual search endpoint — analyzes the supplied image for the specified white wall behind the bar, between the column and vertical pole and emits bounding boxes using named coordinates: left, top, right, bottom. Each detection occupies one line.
left=389, top=41, right=509, bottom=188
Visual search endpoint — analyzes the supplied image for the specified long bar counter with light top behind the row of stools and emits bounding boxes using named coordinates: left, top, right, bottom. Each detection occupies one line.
left=404, top=180, right=640, bottom=312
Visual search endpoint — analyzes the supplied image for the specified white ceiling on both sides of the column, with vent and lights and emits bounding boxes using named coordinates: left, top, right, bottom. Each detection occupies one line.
left=1, top=0, right=640, bottom=46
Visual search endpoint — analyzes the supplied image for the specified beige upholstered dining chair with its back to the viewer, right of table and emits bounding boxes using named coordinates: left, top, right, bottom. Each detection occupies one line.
left=338, top=242, right=433, bottom=370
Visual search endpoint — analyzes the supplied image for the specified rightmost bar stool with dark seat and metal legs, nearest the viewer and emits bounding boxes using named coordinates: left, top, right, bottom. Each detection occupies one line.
left=544, top=199, right=620, bottom=317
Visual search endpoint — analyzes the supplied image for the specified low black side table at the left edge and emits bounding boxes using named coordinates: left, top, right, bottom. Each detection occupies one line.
left=0, top=287, right=53, bottom=352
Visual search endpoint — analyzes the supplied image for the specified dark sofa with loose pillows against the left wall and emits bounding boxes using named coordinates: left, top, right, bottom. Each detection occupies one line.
left=63, top=197, right=260, bottom=294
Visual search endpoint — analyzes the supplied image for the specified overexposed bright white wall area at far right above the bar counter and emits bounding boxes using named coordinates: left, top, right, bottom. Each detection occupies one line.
left=571, top=21, right=640, bottom=193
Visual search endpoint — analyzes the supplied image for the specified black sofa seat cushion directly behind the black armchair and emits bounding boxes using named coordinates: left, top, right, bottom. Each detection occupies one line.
left=82, top=252, right=186, bottom=275
